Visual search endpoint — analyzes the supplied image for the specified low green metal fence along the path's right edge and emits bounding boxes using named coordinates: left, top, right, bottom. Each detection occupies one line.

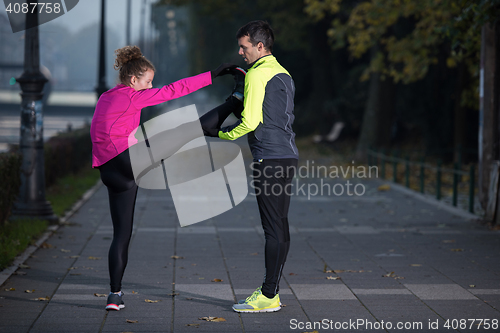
left=368, top=149, right=475, bottom=213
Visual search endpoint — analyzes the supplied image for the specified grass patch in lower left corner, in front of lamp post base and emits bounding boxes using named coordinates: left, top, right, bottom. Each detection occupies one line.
left=0, top=219, right=48, bottom=271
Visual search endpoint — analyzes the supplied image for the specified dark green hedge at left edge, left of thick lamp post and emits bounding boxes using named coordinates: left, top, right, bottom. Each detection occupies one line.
left=0, top=153, right=21, bottom=225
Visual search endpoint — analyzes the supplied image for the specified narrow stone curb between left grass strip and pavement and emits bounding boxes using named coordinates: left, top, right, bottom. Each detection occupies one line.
left=0, top=180, right=102, bottom=286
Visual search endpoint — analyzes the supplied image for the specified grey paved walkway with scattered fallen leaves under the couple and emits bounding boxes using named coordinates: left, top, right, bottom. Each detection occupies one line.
left=0, top=160, right=500, bottom=333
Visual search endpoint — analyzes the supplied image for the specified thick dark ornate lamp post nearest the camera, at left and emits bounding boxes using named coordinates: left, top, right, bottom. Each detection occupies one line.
left=12, top=10, right=59, bottom=223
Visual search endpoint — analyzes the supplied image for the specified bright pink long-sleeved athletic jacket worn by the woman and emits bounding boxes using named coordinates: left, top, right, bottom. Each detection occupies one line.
left=90, top=72, right=212, bottom=168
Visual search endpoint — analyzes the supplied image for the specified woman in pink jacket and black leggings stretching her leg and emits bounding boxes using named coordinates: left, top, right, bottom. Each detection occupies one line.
left=90, top=46, right=234, bottom=310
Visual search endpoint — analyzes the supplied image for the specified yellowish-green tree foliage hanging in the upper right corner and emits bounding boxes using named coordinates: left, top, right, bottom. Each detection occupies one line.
left=305, top=0, right=500, bottom=108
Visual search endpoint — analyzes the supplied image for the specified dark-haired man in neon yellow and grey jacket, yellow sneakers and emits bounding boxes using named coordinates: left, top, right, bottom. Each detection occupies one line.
left=218, top=21, right=298, bottom=312
